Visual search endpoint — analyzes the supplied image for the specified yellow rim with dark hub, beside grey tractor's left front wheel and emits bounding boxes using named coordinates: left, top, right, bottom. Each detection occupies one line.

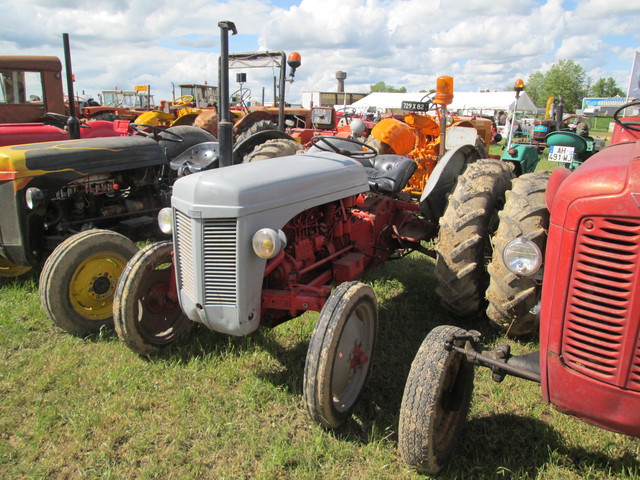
left=69, top=253, right=127, bottom=321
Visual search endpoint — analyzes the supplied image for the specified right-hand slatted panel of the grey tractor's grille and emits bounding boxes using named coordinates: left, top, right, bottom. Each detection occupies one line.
left=202, top=218, right=238, bottom=306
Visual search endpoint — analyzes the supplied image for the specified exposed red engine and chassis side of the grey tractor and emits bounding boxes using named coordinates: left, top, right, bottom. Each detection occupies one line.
left=261, top=194, right=428, bottom=326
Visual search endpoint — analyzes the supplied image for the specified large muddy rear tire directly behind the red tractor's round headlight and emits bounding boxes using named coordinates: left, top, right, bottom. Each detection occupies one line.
left=487, top=171, right=549, bottom=336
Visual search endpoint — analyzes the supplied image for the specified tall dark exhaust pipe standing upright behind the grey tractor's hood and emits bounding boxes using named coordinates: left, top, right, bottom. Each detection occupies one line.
left=218, top=21, right=238, bottom=167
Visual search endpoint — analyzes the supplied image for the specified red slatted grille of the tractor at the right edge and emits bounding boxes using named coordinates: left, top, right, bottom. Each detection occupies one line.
left=562, top=217, right=640, bottom=391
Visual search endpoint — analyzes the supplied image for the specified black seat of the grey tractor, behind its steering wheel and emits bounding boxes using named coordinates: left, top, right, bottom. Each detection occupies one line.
left=355, top=155, right=417, bottom=195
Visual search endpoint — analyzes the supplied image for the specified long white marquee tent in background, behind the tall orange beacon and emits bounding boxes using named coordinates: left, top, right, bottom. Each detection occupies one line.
left=351, top=91, right=538, bottom=115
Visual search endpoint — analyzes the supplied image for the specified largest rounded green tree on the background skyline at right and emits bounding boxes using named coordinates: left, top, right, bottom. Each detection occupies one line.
left=527, top=60, right=587, bottom=112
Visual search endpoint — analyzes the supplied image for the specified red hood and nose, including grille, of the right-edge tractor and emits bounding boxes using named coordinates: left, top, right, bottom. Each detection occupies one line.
left=540, top=138, right=640, bottom=436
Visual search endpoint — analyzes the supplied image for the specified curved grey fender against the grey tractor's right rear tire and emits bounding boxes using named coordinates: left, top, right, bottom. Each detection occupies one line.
left=420, top=145, right=482, bottom=223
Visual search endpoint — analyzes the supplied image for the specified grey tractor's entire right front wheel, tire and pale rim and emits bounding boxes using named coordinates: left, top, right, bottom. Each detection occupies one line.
left=303, top=281, right=378, bottom=429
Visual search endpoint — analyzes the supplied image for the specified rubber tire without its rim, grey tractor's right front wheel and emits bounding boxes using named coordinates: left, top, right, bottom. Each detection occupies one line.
left=303, top=281, right=378, bottom=429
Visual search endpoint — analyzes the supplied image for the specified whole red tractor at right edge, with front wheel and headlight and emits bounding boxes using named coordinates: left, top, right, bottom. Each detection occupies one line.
left=399, top=102, right=640, bottom=474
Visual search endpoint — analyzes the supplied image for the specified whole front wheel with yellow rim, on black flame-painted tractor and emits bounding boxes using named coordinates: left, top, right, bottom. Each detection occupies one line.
left=39, top=229, right=138, bottom=336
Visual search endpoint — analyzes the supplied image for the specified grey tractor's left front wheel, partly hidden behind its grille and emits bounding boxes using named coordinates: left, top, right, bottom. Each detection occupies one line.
left=113, top=242, right=193, bottom=356
